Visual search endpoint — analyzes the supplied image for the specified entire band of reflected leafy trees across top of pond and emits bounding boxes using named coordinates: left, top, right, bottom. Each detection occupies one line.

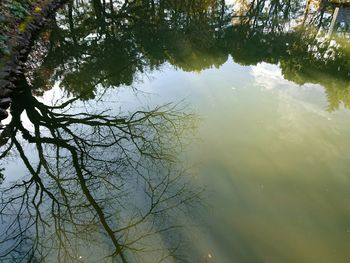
left=27, top=0, right=350, bottom=110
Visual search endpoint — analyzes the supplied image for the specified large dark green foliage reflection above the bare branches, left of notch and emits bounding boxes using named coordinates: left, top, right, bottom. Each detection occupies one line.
left=28, top=0, right=230, bottom=98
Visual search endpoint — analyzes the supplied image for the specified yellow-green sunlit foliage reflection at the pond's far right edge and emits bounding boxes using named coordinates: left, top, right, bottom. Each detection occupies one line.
left=280, top=32, right=350, bottom=111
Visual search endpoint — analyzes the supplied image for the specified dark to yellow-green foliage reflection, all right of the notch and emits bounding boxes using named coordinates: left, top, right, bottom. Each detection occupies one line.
left=227, top=21, right=350, bottom=111
